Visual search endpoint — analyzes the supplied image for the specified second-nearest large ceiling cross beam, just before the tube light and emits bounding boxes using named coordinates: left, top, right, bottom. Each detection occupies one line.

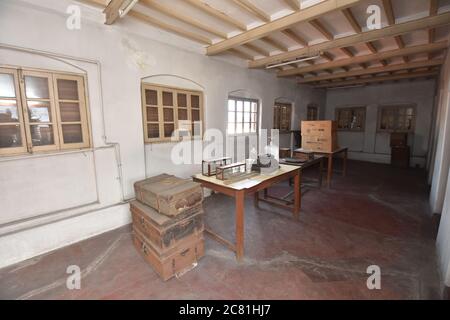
left=248, top=9, right=450, bottom=68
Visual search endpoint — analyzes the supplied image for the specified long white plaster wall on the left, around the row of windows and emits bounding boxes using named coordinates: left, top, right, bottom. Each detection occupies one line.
left=0, top=0, right=324, bottom=267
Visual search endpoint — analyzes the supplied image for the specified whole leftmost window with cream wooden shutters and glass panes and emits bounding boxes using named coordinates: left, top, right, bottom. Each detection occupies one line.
left=0, top=68, right=90, bottom=155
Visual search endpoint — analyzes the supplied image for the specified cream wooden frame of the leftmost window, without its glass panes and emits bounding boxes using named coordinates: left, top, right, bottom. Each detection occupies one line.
left=0, top=66, right=92, bottom=156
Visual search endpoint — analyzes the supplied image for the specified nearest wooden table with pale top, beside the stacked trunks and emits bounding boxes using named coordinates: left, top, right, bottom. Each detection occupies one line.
left=193, top=164, right=301, bottom=261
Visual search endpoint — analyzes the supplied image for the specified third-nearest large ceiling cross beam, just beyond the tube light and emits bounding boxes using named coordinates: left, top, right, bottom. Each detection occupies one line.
left=278, top=41, right=448, bottom=77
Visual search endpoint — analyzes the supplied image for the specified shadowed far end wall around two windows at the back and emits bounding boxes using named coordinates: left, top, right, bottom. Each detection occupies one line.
left=325, top=80, right=435, bottom=167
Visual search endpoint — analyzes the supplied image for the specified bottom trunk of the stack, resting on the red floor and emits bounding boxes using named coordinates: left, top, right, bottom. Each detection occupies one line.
left=133, top=228, right=204, bottom=281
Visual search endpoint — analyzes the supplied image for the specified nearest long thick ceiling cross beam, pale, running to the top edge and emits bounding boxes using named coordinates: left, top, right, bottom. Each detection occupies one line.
left=206, top=0, right=361, bottom=55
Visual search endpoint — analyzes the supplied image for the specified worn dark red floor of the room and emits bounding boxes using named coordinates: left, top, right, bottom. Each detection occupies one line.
left=0, top=161, right=441, bottom=299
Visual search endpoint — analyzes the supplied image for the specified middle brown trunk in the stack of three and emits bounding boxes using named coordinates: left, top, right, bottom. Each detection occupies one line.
left=130, top=201, right=204, bottom=254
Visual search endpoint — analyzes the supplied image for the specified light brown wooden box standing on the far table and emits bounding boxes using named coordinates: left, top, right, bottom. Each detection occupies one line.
left=301, top=121, right=338, bottom=152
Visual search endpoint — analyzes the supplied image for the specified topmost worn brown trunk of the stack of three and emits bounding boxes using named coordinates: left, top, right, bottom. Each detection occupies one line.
left=134, top=174, right=203, bottom=216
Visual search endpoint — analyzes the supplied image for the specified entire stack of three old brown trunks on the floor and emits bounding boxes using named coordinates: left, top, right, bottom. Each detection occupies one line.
left=130, top=174, right=204, bottom=280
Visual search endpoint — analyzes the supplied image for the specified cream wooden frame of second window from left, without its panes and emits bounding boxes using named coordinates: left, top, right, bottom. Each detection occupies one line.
left=141, top=82, right=204, bottom=144
